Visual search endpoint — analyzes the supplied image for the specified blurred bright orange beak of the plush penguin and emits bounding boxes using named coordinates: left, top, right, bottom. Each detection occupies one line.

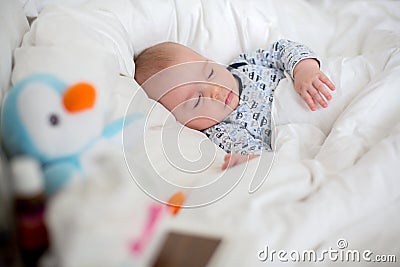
left=63, top=83, right=96, bottom=112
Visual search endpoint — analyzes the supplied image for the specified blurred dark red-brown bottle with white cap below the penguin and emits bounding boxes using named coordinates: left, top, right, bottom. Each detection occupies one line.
left=10, top=157, right=49, bottom=267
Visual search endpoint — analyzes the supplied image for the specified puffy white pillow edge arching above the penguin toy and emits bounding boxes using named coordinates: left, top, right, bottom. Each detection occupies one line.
left=22, top=6, right=134, bottom=77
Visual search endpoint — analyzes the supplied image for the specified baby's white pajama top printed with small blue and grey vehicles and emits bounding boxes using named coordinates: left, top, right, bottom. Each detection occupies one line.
left=203, top=40, right=316, bottom=155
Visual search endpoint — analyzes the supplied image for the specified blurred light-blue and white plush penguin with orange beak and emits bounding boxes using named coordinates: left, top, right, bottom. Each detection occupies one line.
left=1, top=74, right=142, bottom=195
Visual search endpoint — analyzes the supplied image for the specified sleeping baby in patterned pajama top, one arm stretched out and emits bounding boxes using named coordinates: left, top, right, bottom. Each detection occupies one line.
left=135, top=40, right=335, bottom=169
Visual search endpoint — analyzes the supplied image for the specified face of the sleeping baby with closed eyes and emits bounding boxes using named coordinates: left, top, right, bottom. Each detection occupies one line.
left=144, top=47, right=239, bottom=130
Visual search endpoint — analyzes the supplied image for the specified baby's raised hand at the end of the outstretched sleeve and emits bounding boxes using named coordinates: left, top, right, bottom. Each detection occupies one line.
left=293, top=58, right=335, bottom=111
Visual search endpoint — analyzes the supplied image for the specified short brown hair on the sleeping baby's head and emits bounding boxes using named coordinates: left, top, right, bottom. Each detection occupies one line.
left=134, top=42, right=177, bottom=85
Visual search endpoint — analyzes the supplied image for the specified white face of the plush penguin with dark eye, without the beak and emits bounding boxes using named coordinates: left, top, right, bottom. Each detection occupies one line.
left=17, top=82, right=103, bottom=158
